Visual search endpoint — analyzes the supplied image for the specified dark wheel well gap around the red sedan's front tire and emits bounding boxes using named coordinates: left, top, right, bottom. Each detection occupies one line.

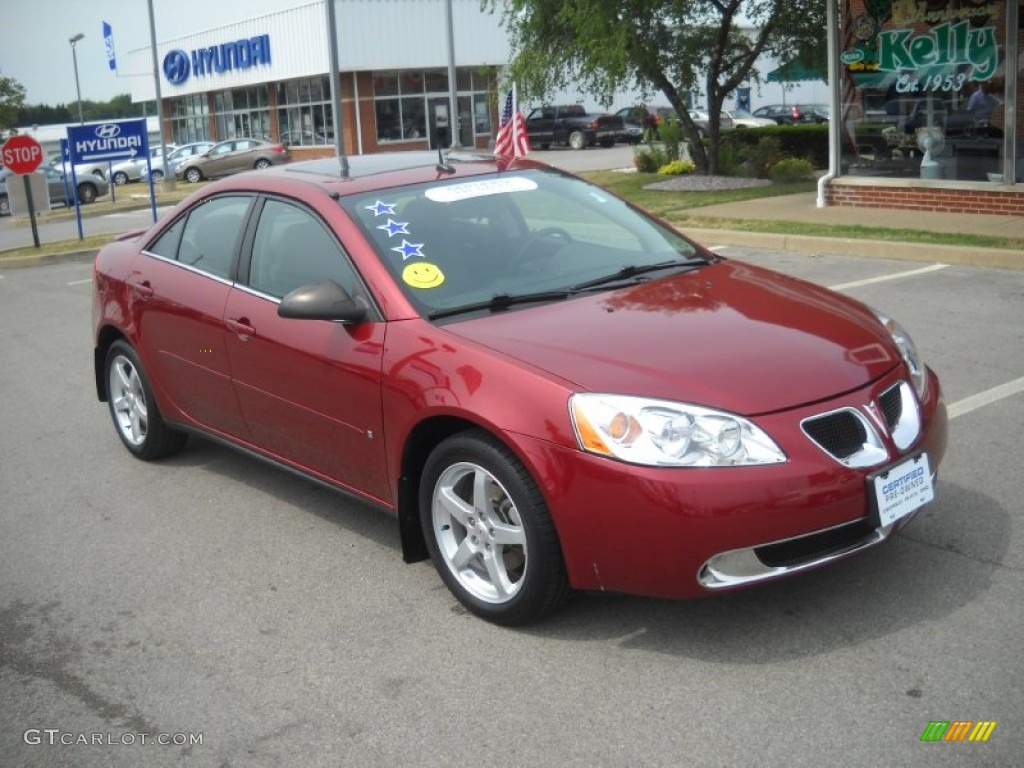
left=398, top=416, right=480, bottom=562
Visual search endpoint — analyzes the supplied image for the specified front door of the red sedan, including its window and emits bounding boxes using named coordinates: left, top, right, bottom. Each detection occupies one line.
left=224, top=198, right=390, bottom=502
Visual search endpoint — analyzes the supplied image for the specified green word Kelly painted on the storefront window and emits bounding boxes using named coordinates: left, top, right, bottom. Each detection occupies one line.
left=879, top=19, right=999, bottom=81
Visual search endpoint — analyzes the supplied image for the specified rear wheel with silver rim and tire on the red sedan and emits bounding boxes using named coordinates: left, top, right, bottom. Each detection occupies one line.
left=103, top=341, right=188, bottom=461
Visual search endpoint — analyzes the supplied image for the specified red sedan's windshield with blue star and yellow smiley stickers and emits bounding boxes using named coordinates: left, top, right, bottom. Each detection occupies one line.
left=340, top=169, right=702, bottom=316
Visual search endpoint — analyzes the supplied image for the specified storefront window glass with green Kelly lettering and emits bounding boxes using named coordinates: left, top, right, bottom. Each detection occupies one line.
left=839, top=0, right=1013, bottom=181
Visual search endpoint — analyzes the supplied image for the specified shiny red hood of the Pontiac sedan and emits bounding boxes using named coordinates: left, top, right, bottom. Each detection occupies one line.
left=445, top=261, right=899, bottom=416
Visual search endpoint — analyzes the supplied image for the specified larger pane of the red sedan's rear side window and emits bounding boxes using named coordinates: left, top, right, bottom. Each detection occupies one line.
left=178, top=197, right=251, bottom=280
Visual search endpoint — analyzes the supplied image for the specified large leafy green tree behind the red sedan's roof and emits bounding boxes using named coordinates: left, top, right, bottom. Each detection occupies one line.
left=481, top=0, right=835, bottom=174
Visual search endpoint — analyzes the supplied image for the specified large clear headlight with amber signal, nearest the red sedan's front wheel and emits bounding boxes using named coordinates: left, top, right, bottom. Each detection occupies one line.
left=569, top=392, right=785, bottom=467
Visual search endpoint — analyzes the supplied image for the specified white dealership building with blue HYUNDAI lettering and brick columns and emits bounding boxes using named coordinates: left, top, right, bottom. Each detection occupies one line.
left=127, top=0, right=509, bottom=157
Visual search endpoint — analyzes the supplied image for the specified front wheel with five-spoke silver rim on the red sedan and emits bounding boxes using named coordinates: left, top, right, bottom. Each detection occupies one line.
left=420, top=429, right=572, bottom=627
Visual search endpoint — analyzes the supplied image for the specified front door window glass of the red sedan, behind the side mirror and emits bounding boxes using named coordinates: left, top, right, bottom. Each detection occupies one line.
left=249, top=200, right=356, bottom=299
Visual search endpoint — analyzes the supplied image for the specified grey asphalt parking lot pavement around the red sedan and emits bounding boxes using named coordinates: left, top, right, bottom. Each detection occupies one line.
left=0, top=248, right=1024, bottom=768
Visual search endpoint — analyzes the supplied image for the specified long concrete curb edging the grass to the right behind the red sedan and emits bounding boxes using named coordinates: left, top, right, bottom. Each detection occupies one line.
left=679, top=227, right=1024, bottom=269
